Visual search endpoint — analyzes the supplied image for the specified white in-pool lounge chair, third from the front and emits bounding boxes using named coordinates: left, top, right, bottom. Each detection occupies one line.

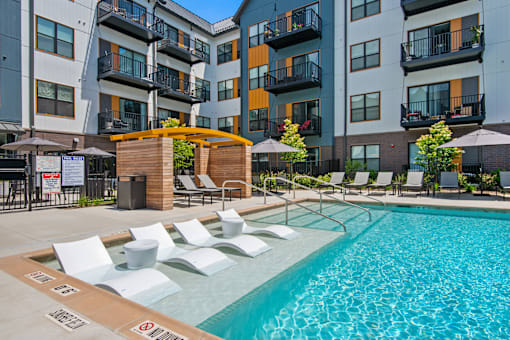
left=174, top=218, right=271, bottom=257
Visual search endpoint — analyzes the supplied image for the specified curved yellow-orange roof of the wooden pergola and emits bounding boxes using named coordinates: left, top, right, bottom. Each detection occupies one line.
left=110, top=127, right=253, bottom=147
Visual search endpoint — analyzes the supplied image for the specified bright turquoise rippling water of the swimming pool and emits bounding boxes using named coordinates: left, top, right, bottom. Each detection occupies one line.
left=199, top=205, right=510, bottom=340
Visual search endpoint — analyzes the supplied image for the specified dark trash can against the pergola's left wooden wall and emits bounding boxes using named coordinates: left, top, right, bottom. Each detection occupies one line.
left=117, top=175, right=145, bottom=210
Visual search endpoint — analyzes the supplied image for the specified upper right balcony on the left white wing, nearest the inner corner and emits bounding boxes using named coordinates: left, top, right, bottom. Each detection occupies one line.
left=158, top=33, right=210, bottom=65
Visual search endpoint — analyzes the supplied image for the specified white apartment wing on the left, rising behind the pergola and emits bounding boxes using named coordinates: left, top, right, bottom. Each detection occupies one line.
left=5, top=0, right=240, bottom=151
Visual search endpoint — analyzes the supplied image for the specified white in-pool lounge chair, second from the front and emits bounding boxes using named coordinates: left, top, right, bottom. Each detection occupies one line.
left=129, top=223, right=236, bottom=276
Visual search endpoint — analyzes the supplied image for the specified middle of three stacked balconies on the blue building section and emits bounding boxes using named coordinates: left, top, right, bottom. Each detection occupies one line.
left=264, top=62, right=321, bottom=95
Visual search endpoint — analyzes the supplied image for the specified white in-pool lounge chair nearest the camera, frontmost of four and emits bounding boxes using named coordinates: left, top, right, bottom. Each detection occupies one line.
left=53, top=236, right=181, bottom=305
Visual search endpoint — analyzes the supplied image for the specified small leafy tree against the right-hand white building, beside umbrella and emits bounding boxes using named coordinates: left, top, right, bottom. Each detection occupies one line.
left=416, top=121, right=462, bottom=181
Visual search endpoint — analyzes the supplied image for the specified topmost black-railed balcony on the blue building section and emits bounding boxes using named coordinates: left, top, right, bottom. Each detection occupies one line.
left=264, top=8, right=322, bottom=50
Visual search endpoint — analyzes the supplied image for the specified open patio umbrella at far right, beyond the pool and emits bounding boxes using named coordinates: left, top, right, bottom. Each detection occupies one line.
left=438, top=128, right=510, bottom=193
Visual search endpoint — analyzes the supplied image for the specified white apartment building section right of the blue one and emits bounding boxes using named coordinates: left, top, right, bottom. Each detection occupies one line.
left=335, top=0, right=510, bottom=171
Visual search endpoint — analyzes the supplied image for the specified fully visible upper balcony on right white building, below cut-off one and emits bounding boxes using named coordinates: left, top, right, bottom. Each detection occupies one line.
left=400, top=25, right=485, bottom=75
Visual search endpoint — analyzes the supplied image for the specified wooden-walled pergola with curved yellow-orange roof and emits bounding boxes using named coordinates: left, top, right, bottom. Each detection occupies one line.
left=110, top=127, right=253, bottom=210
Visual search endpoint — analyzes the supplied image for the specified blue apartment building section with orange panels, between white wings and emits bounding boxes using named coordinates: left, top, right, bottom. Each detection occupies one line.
left=234, top=0, right=334, bottom=165
